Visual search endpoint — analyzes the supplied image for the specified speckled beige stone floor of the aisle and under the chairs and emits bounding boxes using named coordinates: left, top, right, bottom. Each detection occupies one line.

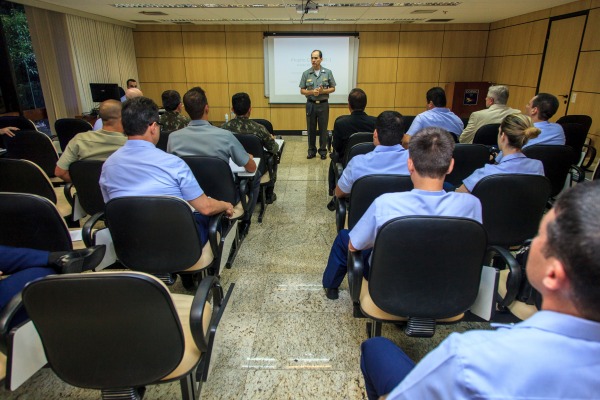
left=0, top=137, right=490, bottom=399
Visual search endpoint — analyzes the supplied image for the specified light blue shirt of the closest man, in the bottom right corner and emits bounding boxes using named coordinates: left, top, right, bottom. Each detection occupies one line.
left=387, top=311, right=600, bottom=400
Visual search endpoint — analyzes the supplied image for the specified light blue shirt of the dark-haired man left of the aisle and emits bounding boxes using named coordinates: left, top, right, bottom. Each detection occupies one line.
left=100, top=140, right=204, bottom=202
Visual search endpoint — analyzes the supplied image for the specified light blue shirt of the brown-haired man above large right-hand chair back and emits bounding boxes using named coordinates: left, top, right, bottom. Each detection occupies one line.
left=350, top=189, right=481, bottom=250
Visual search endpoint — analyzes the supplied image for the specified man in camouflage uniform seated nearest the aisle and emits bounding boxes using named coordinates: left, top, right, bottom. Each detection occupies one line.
left=221, top=93, right=279, bottom=204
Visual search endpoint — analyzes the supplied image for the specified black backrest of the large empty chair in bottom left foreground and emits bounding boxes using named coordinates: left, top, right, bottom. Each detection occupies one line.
left=23, top=272, right=185, bottom=389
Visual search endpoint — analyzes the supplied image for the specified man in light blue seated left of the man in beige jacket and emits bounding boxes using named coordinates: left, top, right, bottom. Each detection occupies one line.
left=404, top=87, right=465, bottom=142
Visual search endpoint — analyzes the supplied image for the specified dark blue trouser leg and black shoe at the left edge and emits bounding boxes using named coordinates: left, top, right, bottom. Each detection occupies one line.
left=0, top=245, right=106, bottom=326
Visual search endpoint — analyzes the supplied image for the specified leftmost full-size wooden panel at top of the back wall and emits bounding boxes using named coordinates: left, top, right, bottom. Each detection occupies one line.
left=133, top=32, right=183, bottom=58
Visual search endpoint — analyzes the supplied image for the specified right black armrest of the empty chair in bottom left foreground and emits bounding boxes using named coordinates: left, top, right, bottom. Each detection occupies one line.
left=190, top=275, right=223, bottom=353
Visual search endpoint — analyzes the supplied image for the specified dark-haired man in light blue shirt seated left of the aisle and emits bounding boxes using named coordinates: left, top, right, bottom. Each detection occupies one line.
left=100, top=97, right=233, bottom=245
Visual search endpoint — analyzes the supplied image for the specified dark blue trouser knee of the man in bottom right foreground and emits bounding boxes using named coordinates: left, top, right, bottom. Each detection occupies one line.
left=360, top=337, right=415, bottom=400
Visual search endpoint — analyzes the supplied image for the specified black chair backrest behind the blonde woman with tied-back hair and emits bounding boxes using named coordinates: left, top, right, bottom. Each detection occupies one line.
left=471, top=174, right=550, bottom=247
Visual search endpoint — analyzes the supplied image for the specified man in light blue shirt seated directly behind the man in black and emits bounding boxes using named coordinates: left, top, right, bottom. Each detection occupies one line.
left=335, top=111, right=408, bottom=199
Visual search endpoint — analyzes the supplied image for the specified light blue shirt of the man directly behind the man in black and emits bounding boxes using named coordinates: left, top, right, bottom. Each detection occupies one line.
left=338, top=144, right=409, bottom=193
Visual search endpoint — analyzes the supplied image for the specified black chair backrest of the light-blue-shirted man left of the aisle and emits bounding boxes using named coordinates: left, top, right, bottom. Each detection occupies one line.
left=105, top=196, right=202, bottom=274
